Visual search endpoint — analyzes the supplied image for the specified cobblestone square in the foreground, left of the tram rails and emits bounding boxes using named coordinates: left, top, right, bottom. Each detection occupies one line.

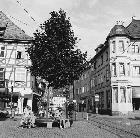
left=0, top=119, right=118, bottom=138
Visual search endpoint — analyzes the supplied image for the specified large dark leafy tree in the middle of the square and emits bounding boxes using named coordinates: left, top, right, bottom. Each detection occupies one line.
left=28, top=9, right=87, bottom=88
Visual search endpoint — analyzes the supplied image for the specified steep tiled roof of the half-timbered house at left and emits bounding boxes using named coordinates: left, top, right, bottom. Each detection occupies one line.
left=0, top=11, right=33, bottom=41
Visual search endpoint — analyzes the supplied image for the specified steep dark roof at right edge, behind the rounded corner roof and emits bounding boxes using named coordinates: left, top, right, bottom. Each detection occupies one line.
left=126, top=19, right=140, bottom=38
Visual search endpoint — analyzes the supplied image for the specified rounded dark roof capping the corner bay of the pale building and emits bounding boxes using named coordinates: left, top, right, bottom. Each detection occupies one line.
left=108, top=25, right=130, bottom=37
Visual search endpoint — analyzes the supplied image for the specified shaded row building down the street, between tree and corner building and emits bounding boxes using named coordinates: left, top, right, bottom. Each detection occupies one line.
left=73, top=67, right=94, bottom=112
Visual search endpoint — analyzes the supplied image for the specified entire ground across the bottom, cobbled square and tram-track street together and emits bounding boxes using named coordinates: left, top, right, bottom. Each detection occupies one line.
left=0, top=111, right=140, bottom=138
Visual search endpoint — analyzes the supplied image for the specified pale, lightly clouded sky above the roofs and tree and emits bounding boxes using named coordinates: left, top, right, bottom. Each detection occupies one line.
left=0, top=0, right=140, bottom=59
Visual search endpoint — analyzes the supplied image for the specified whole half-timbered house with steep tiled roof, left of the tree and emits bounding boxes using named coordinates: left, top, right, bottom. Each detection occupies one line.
left=0, top=12, right=38, bottom=114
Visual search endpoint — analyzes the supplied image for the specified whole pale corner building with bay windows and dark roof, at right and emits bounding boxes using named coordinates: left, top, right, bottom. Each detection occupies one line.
left=91, top=19, right=140, bottom=115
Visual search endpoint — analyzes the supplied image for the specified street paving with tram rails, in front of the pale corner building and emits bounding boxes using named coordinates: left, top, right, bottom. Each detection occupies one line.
left=89, top=111, right=140, bottom=137
